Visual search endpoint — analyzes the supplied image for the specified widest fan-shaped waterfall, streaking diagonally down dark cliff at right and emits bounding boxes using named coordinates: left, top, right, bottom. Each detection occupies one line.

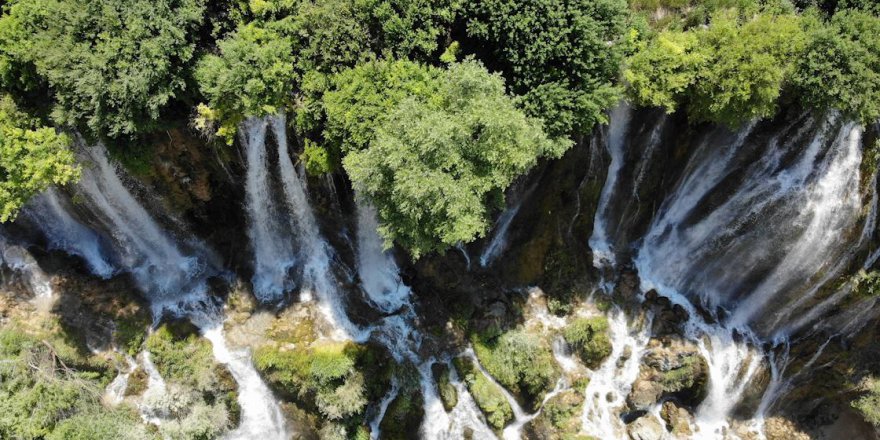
left=636, top=115, right=861, bottom=328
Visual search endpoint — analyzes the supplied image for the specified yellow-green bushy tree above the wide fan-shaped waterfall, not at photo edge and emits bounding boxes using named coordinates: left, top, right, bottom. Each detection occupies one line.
left=624, top=10, right=806, bottom=127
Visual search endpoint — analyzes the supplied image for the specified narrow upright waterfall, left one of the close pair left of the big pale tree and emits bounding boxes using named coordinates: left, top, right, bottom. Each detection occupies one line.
left=240, top=118, right=296, bottom=302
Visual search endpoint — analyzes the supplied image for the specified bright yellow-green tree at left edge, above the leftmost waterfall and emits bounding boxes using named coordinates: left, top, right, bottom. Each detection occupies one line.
left=0, top=95, right=80, bottom=222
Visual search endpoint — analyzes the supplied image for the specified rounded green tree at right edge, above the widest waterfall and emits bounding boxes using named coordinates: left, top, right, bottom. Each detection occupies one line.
left=793, top=11, right=880, bottom=124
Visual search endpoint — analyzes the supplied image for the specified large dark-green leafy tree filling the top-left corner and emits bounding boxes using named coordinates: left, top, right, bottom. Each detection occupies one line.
left=0, top=0, right=204, bottom=137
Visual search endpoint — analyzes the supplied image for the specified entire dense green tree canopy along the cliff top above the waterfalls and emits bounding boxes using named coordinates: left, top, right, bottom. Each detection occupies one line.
left=0, top=0, right=880, bottom=257
